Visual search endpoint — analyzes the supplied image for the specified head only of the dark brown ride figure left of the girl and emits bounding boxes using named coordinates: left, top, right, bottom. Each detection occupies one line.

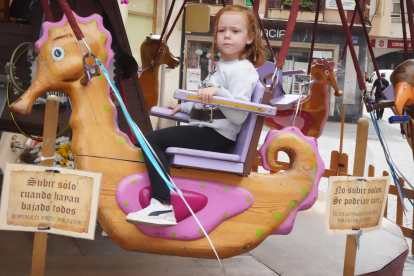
left=141, top=34, right=180, bottom=70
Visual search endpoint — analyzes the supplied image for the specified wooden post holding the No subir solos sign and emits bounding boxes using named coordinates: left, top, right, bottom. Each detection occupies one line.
left=343, top=118, right=369, bottom=276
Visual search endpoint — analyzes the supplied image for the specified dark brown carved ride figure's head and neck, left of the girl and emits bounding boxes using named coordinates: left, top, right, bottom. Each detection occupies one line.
left=139, top=34, right=180, bottom=111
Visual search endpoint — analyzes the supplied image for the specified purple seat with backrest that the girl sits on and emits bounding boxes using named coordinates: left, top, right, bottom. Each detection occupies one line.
left=166, top=80, right=271, bottom=175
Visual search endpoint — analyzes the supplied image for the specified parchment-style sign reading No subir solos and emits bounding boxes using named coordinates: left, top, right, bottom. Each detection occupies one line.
left=325, top=176, right=390, bottom=235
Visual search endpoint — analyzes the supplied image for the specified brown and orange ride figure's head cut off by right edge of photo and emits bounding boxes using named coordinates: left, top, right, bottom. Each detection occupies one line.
left=390, top=59, right=414, bottom=117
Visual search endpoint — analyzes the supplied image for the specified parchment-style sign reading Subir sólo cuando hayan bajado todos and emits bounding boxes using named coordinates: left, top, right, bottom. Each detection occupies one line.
left=0, top=164, right=102, bottom=239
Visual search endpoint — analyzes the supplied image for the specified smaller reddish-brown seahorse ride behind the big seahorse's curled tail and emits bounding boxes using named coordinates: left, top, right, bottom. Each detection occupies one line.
left=265, top=58, right=343, bottom=138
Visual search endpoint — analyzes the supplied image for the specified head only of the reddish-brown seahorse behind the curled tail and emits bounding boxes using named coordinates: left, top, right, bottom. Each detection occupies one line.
left=311, top=58, right=344, bottom=97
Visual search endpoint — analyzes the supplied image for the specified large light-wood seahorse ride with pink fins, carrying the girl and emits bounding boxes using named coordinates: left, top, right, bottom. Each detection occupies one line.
left=10, top=14, right=325, bottom=258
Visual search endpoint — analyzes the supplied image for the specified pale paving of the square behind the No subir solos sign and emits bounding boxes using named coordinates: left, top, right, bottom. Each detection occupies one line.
left=259, top=106, right=414, bottom=276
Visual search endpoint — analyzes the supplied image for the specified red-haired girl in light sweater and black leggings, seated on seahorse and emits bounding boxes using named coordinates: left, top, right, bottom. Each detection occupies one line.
left=126, top=5, right=266, bottom=227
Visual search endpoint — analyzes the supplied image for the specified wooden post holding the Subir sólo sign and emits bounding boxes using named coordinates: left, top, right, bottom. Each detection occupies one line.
left=31, top=96, right=59, bottom=276
